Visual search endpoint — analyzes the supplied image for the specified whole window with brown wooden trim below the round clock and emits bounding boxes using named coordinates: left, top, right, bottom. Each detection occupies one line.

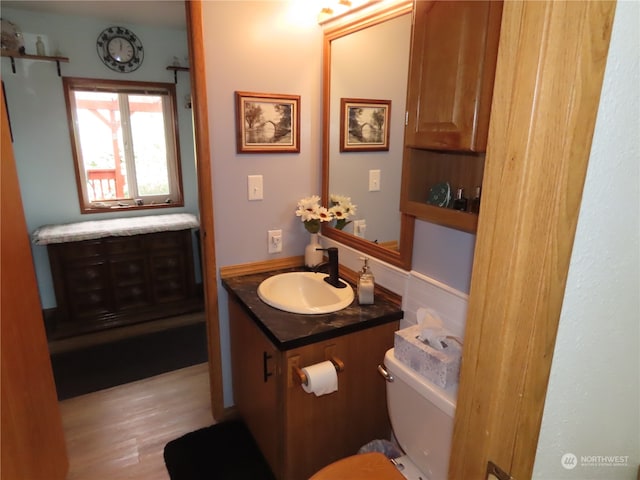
left=63, top=77, right=184, bottom=213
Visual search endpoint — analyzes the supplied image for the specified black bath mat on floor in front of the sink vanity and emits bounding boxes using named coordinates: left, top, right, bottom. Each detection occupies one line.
left=164, top=421, right=275, bottom=480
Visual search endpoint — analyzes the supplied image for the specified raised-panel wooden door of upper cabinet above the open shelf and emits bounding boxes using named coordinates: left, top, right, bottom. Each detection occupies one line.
left=405, top=1, right=502, bottom=152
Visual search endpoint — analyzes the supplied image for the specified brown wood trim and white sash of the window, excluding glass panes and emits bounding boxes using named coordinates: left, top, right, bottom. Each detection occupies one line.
left=63, top=77, right=184, bottom=213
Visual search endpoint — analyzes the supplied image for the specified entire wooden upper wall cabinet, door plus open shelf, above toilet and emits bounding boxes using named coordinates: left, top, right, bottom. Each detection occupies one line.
left=400, top=1, right=502, bottom=233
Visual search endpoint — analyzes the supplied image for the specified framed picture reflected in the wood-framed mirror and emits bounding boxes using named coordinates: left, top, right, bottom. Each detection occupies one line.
left=340, top=98, right=391, bottom=152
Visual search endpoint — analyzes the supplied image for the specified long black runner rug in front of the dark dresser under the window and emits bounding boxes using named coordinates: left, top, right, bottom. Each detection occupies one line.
left=51, top=322, right=207, bottom=400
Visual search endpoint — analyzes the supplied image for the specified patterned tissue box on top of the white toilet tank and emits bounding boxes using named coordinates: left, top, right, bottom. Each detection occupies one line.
left=393, top=325, right=462, bottom=388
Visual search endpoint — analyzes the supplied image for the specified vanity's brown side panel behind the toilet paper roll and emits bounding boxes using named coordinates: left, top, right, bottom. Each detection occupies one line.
left=278, top=322, right=398, bottom=480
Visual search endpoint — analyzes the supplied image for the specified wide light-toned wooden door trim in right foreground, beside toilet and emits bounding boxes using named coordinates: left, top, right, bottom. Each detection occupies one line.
left=449, top=1, right=615, bottom=480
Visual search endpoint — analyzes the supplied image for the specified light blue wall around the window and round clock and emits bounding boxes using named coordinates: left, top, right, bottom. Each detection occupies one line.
left=1, top=8, right=198, bottom=308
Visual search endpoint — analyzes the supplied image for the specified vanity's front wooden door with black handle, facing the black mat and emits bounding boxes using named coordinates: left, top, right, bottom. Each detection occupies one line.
left=229, top=297, right=283, bottom=478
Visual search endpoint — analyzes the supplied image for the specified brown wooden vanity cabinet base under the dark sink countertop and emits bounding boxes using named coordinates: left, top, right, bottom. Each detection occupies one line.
left=229, top=297, right=398, bottom=480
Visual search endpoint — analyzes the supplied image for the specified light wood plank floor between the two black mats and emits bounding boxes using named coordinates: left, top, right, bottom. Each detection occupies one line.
left=60, top=363, right=215, bottom=480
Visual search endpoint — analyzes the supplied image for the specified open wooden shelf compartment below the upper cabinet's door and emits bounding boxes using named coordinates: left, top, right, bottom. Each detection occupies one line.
left=400, top=147, right=484, bottom=233
